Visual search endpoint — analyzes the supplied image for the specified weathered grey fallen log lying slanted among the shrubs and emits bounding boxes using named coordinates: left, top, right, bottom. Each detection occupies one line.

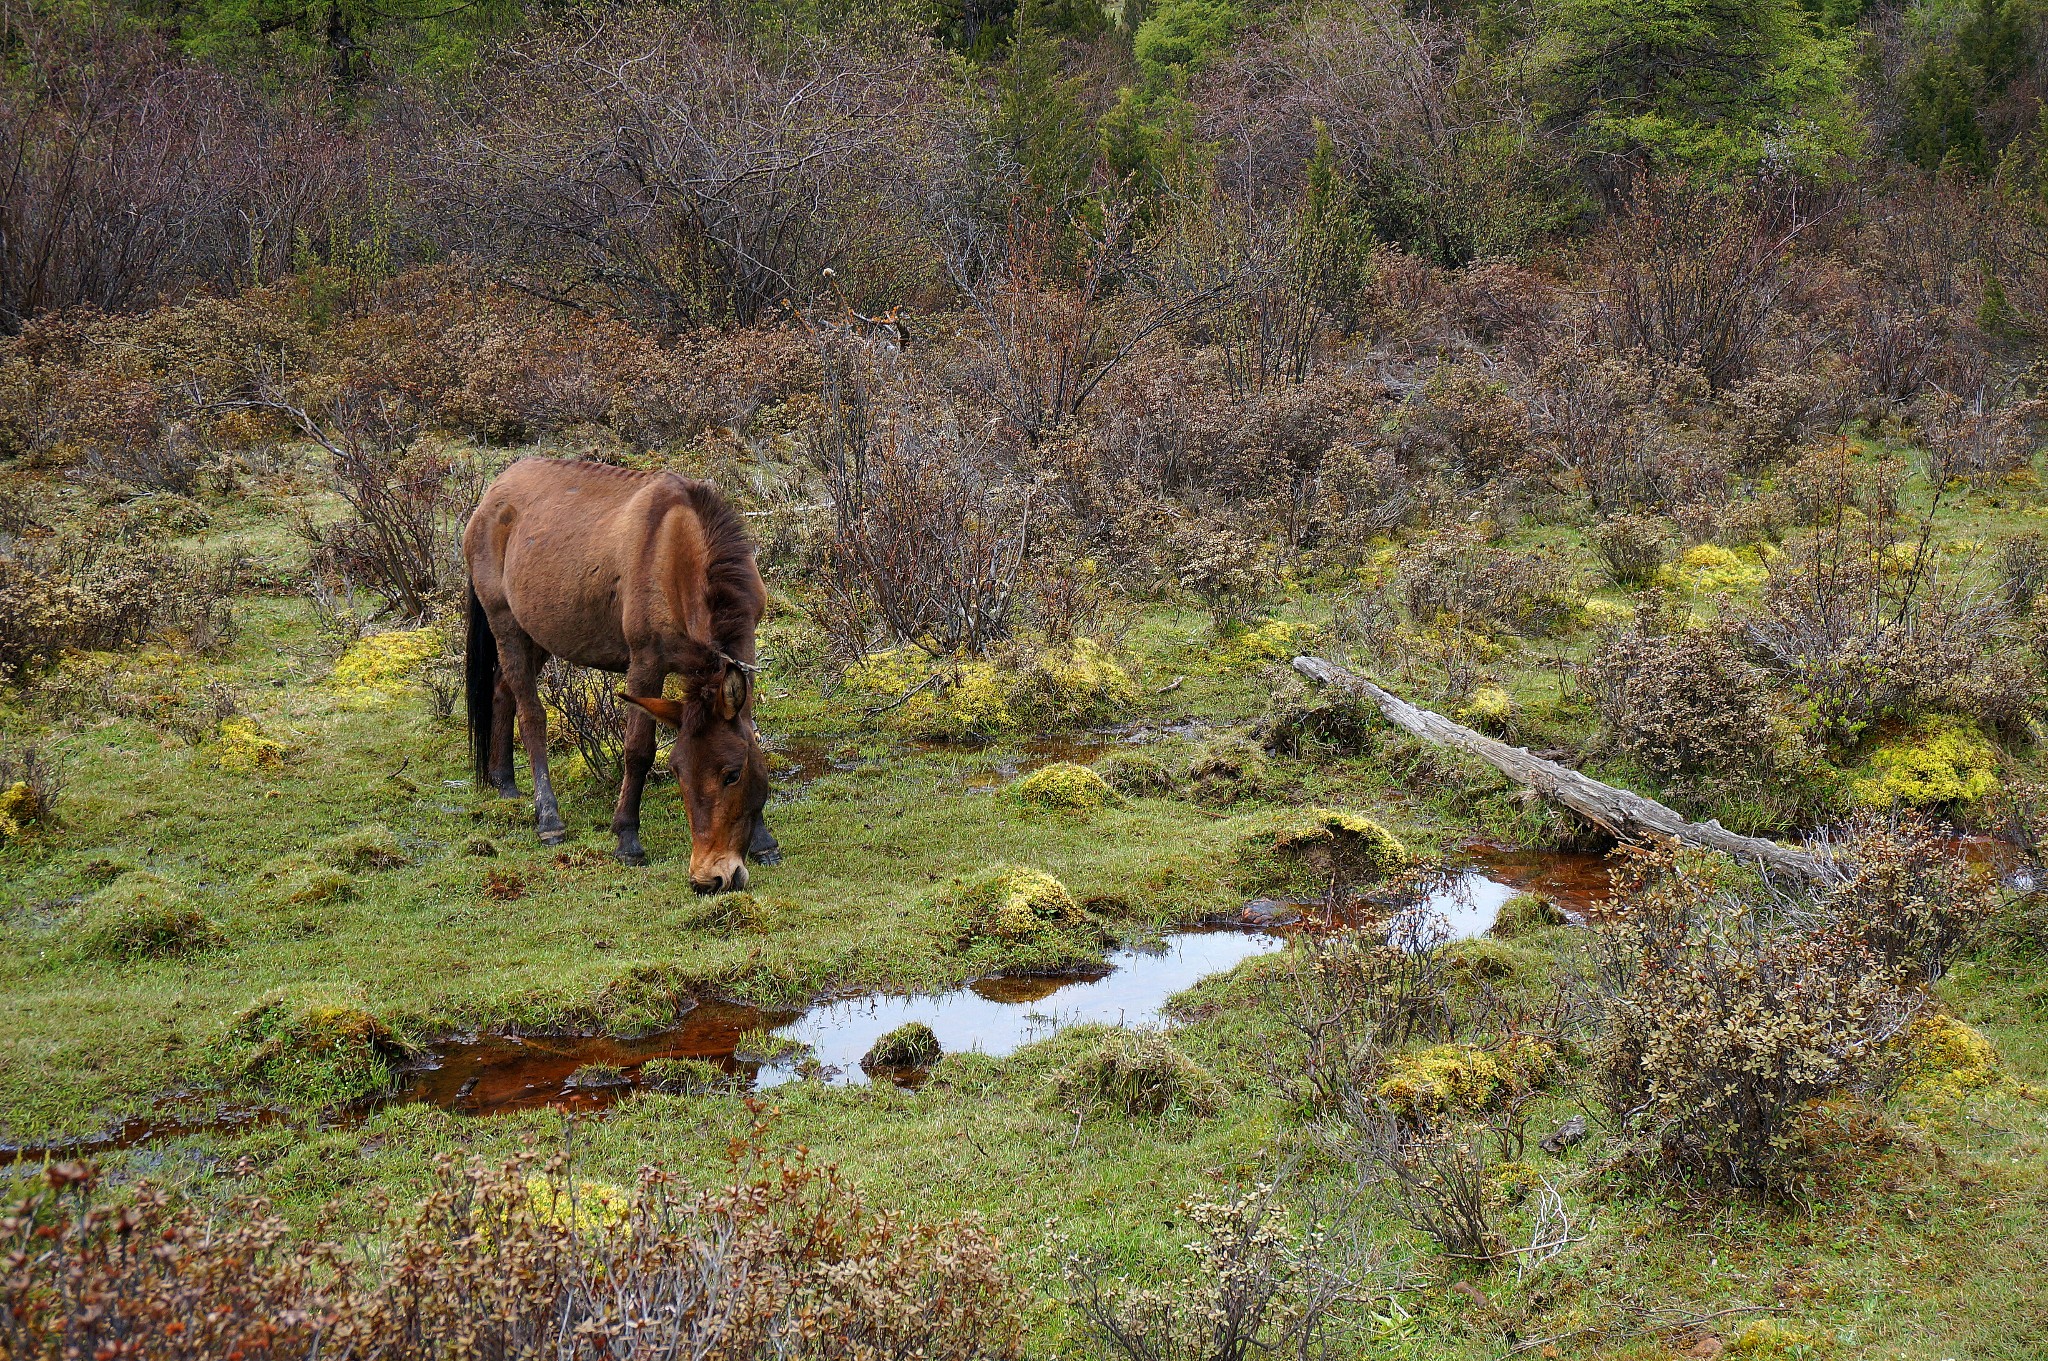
left=1294, top=657, right=1835, bottom=884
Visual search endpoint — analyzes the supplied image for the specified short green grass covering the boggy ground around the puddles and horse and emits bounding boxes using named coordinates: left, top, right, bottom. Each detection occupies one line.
left=0, top=454, right=2048, bottom=1361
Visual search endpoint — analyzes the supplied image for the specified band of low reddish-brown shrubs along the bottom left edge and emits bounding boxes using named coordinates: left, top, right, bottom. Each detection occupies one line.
left=0, top=1130, right=1020, bottom=1361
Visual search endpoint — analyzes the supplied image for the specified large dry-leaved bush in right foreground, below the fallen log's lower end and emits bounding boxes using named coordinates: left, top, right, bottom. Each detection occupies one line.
left=1593, top=855, right=1925, bottom=1191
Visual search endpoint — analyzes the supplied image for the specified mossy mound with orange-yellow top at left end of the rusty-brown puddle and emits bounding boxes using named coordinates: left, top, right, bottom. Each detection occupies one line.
left=227, top=991, right=406, bottom=1105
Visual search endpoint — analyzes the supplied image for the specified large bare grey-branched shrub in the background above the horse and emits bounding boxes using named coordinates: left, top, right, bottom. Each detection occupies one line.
left=438, top=8, right=958, bottom=332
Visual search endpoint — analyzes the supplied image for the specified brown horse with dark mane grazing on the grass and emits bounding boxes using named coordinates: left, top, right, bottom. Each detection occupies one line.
left=463, top=458, right=778, bottom=892
